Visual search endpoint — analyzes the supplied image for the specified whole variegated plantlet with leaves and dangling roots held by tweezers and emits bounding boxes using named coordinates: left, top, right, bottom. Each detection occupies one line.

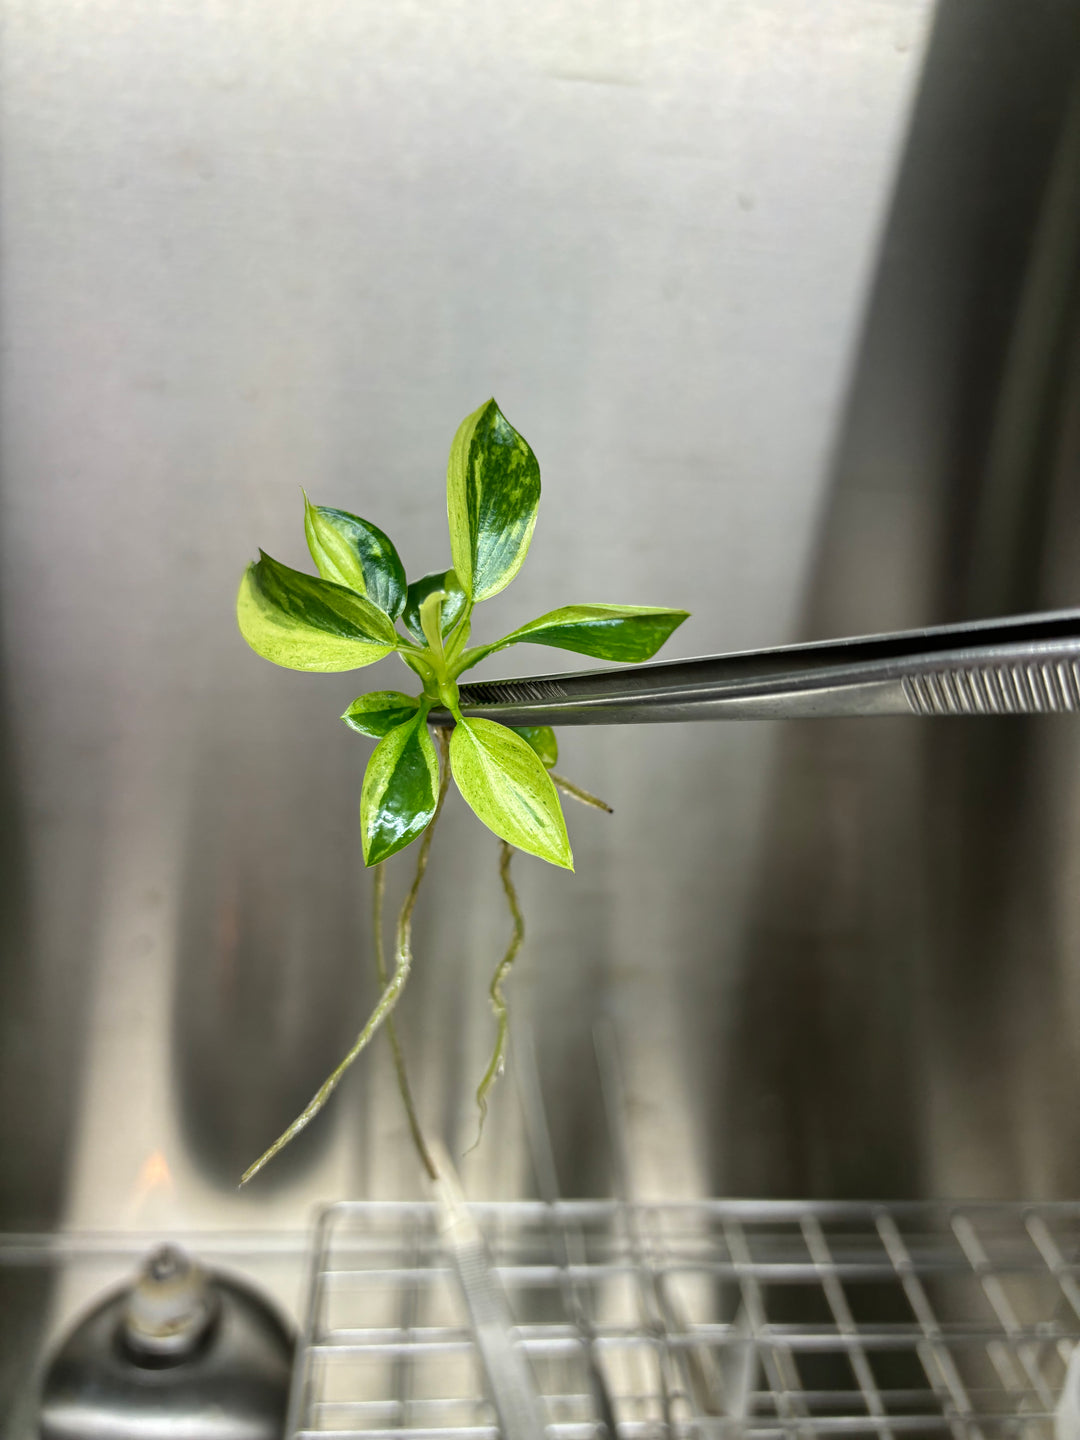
left=236, top=400, right=687, bottom=1184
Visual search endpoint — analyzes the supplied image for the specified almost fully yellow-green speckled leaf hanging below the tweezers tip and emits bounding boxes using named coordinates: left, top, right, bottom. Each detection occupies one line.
left=451, top=720, right=573, bottom=870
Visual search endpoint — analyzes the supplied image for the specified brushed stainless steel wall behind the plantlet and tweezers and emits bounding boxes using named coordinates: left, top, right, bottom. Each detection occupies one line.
left=0, top=0, right=1080, bottom=1405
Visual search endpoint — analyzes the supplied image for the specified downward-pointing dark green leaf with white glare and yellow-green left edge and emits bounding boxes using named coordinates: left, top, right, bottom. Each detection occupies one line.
left=360, top=706, right=439, bottom=865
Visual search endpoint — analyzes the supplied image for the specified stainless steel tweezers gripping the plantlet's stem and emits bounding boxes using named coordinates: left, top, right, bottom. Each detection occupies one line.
left=431, top=611, right=1080, bottom=726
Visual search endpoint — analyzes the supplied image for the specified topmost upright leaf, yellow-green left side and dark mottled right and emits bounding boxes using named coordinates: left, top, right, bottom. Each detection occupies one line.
left=446, top=400, right=540, bottom=600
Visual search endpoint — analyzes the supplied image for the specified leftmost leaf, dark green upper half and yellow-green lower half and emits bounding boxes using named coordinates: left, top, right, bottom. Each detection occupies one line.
left=236, top=552, right=397, bottom=671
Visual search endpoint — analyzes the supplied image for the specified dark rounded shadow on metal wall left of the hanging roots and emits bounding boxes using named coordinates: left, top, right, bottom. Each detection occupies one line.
left=171, top=676, right=373, bottom=1189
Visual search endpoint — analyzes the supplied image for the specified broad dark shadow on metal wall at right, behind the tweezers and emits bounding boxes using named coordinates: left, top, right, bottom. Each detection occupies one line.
left=717, top=0, right=1080, bottom=1197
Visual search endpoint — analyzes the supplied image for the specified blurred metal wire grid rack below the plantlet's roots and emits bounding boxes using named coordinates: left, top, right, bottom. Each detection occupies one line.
left=285, top=1201, right=1080, bottom=1440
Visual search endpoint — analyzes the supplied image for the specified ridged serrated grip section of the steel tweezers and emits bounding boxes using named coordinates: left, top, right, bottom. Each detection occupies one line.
left=904, top=660, right=1080, bottom=716
